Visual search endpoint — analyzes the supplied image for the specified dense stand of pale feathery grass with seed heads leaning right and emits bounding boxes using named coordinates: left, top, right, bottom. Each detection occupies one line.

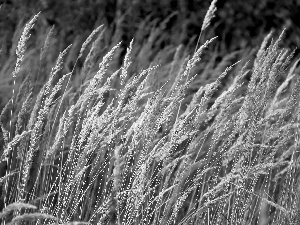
left=0, top=1, right=300, bottom=225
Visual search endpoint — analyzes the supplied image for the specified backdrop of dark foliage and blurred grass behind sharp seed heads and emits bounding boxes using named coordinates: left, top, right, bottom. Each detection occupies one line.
left=0, top=0, right=300, bottom=109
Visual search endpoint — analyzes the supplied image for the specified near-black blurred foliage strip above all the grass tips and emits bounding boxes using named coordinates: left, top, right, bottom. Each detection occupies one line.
left=0, top=0, right=300, bottom=52
